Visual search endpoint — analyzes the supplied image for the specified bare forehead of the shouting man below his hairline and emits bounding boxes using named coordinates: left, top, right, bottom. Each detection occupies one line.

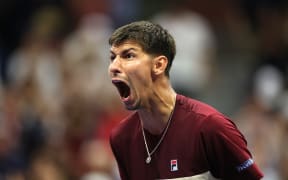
left=110, top=41, right=143, bottom=54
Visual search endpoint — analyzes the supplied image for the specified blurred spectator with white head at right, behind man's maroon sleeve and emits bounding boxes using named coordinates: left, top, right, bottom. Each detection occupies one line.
left=235, top=66, right=287, bottom=180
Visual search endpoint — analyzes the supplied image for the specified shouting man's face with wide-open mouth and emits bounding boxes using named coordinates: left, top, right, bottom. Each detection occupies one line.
left=108, top=41, right=153, bottom=110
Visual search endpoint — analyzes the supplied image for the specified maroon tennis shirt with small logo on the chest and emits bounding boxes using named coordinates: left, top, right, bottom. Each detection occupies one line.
left=110, top=94, right=263, bottom=180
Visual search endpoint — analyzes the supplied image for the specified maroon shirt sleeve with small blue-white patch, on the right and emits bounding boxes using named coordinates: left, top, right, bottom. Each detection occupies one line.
left=202, top=114, right=263, bottom=180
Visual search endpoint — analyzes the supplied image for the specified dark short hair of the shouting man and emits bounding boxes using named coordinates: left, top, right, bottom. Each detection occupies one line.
left=109, top=21, right=176, bottom=77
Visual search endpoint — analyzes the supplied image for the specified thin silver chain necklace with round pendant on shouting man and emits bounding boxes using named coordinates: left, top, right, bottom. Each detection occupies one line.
left=141, top=108, right=174, bottom=164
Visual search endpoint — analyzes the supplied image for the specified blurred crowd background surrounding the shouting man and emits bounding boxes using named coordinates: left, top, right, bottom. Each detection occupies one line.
left=0, top=0, right=288, bottom=180
